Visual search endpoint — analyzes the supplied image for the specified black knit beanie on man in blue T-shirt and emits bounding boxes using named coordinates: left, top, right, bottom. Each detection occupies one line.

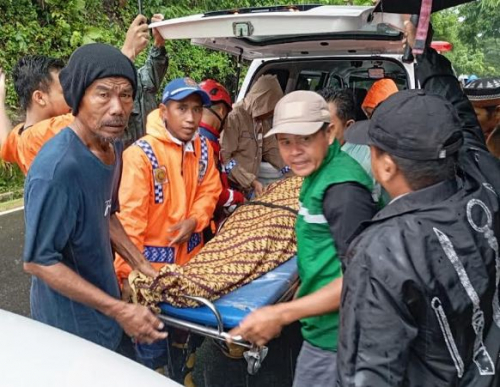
left=59, top=43, right=137, bottom=116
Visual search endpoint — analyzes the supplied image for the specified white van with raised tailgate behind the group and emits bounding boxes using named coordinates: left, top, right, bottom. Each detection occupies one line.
left=150, top=5, right=416, bottom=184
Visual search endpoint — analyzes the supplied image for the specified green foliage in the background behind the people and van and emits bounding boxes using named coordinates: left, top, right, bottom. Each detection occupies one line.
left=0, top=0, right=492, bottom=192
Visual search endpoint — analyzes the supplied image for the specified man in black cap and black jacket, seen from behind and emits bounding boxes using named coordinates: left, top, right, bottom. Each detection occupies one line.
left=337, top=33, right=500, bottom=387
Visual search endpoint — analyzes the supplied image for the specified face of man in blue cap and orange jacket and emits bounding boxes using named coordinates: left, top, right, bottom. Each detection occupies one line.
left=160, top=94, right=203, bottom=142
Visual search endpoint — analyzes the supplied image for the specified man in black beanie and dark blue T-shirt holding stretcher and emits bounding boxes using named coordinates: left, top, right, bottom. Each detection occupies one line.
left=24, top=44, right=166, bottom=350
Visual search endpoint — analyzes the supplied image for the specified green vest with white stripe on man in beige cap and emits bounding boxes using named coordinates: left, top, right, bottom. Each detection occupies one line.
left=295, top=141, right=373, bottom=351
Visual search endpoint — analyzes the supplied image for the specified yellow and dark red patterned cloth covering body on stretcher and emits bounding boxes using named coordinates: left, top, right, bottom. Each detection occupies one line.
left=129, top=177, right=302, bottom=311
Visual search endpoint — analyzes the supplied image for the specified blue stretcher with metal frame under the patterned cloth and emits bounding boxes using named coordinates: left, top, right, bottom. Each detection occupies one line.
left=159, top=257, right=298, bottom=375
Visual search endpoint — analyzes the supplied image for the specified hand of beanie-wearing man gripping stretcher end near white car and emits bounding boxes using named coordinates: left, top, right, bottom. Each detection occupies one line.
left=113, top=302, right=167, bottom=344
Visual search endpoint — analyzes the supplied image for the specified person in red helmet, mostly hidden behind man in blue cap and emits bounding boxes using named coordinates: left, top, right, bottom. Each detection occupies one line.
left=200, top=79, right=245, bottom=226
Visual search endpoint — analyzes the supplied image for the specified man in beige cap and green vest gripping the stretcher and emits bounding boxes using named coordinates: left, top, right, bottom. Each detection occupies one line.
left=231, top=91, right=376, bottom=387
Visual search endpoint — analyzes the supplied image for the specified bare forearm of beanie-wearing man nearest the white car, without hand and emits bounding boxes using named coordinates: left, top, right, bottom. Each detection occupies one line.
left=24, top=263, right=123, bottom=318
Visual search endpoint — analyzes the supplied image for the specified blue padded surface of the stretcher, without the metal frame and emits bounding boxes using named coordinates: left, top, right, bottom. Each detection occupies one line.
left=160, top=257, right=298, bottom=329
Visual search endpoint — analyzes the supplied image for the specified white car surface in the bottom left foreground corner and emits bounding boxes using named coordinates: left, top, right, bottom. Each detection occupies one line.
left=0, top=310, right=180, bottom=387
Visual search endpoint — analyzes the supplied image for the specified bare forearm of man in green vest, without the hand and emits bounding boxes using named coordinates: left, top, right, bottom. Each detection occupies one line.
left=276, top=278, right=342, bottom=325
